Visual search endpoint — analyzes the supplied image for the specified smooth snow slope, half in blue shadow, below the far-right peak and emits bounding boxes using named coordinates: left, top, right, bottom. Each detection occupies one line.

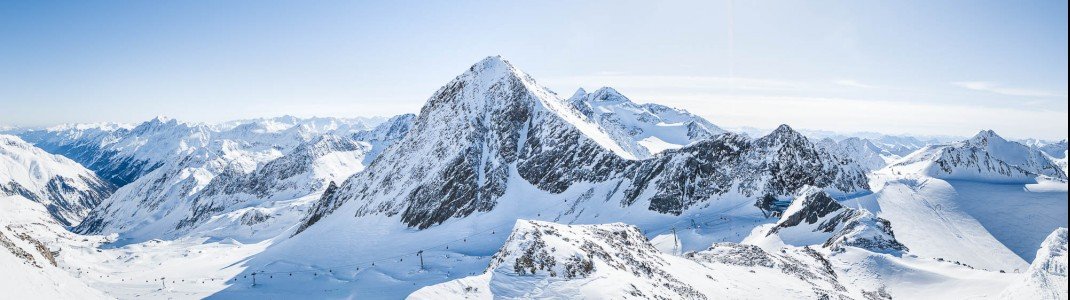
left=844, top=175, right=1067, bottom=272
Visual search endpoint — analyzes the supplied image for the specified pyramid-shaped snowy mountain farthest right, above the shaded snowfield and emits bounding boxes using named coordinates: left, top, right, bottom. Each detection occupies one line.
left=888, top=131, right=1067, bottom=183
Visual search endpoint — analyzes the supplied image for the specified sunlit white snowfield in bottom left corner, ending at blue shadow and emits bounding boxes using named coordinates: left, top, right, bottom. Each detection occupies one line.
left=0, top=191, right=270, bottom=299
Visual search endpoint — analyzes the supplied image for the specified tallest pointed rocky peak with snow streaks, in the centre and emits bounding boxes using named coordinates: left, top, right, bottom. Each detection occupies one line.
left=297, top=57, right=629, bottom=228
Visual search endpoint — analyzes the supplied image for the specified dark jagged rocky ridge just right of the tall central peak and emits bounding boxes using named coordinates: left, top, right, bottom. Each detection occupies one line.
left=625, top=125, right=869, bottom=213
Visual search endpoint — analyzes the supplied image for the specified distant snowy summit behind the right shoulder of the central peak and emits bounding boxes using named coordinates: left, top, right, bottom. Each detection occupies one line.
left=567, top=88, right=724, bottom=159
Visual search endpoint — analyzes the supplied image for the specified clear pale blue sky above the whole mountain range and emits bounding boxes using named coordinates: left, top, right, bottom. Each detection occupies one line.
left=0, top=1, right=1068, bottom=138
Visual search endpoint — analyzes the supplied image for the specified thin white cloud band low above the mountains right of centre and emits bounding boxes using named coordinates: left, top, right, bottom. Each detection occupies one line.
left=540, top=75, right=1067, bottom=138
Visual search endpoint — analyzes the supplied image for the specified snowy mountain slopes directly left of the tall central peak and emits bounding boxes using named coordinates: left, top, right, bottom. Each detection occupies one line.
left=76, top=116, right=411, bottom=240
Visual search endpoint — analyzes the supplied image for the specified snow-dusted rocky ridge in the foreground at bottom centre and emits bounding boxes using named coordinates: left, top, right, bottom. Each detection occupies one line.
left=408, top=220, right=1017, bottom=299
